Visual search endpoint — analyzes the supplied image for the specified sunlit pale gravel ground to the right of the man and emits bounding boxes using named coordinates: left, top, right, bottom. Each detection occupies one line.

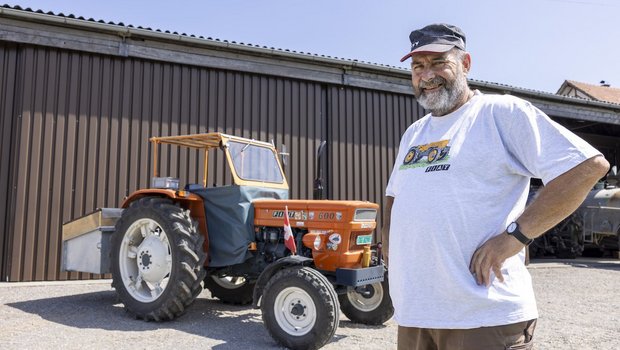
left=530, top=260, right=620, bottom=350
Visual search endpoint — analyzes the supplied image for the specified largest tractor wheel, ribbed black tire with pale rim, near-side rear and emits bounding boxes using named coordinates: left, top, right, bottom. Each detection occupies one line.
left=111, top=197, right=205, bottom=321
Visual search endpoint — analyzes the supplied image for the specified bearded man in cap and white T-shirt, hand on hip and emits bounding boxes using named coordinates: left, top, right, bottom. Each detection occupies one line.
left=383, top=24, right=609, bottom=350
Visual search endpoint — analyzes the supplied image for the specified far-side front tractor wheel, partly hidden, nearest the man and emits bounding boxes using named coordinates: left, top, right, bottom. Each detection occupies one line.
left=338, top=273, right=394, bottom=325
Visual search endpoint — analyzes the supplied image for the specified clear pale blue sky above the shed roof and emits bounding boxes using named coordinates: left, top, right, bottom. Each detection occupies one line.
left=4, top=0, right=620, bottom=93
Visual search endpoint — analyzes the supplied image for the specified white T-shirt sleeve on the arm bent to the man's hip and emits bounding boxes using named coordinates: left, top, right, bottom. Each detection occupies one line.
left=494, top=99, right=601, bottom=184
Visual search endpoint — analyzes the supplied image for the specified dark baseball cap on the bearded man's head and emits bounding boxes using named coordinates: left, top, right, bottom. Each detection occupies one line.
left=400, top=23, right=465, bottom=62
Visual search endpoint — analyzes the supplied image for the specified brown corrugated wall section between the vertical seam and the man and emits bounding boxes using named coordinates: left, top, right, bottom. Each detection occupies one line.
left=328, top=87, right=424, bottom=231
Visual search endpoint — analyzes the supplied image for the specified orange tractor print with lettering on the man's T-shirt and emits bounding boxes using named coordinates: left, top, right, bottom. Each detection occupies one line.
left=399, top=140, right=450, bottom=172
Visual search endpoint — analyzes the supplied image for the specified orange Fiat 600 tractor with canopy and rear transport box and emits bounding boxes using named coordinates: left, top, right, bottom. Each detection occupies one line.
left=63, top=133, right=393, bottom=349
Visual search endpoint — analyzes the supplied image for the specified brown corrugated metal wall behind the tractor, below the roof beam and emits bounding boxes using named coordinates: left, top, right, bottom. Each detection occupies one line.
left=0, top=45, right=420, bottom=281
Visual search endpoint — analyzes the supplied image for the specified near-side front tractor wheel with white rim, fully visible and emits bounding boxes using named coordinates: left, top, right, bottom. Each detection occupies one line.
left=261, top=266, right=340, bottom=349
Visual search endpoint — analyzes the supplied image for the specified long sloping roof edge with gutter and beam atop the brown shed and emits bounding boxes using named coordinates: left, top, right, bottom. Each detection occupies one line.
left=0, top=5, right=620, bottom=125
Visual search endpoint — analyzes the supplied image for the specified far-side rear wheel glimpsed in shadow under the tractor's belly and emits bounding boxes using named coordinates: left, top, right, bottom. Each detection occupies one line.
left=205, top=275, right=256, bottom=305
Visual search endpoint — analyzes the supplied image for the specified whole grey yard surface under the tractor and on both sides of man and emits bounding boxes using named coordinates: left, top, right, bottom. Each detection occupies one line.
left=0, top=259, right=620, bottom=350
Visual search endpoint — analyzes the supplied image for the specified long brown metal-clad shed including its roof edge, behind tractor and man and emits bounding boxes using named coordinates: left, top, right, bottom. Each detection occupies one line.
left=0, top=15, right=620, bottom=281
